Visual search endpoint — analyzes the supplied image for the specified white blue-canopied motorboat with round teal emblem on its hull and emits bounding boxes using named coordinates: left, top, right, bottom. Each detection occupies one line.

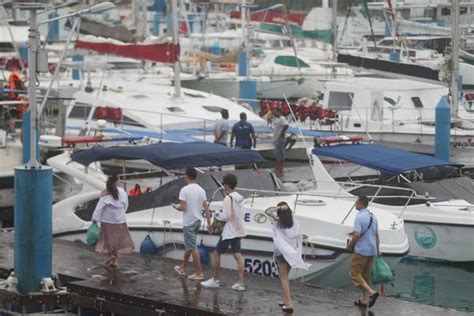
left=312, top=142, right=474, bottom=262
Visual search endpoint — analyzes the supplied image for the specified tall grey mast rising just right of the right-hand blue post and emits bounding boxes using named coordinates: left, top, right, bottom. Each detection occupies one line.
left=451, top=1, right=461, bottom=117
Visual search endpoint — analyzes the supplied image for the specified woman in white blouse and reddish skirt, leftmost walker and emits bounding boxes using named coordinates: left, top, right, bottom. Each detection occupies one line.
left=92, top=175, right=134, bottom=268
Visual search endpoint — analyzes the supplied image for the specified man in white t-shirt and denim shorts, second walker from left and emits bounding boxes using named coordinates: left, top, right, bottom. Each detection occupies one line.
left=173, top=168, right=211, bottom=280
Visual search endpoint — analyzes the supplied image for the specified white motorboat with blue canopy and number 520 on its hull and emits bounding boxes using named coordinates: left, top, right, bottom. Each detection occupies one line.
left=48, top=143, right=408, bottom=278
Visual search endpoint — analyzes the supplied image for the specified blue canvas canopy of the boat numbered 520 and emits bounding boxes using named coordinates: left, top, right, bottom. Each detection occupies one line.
left=71, top=142, right=265, bottom=169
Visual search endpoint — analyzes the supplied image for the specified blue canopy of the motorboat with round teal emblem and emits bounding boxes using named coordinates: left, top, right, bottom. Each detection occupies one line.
left=313, top=144, right=461, bottom=174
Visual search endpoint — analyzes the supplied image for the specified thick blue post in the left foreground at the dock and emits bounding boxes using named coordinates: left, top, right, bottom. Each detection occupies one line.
left=14, top=166, right=53, bottom=294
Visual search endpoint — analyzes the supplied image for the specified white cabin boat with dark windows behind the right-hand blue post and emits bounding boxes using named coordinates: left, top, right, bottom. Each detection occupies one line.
left=313, top=78, right=474, bottom=166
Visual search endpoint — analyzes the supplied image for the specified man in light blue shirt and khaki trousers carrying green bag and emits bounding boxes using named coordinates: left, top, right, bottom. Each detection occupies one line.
left=347, top=196, right=380, bottom=307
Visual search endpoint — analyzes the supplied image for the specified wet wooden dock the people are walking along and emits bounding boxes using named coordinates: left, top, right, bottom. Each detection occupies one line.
left=0, top=232, right=467, bottom=316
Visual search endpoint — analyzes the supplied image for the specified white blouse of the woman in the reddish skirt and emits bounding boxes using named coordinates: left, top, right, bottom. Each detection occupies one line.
left=92, top=188, right=128, bottom=224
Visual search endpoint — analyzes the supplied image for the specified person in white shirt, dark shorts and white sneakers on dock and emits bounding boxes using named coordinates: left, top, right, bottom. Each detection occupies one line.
left=201, top=173, right=247, bottom=291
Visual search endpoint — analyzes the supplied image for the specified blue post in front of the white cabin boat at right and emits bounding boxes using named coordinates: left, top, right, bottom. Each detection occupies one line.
left=435, top=97, right=451, bottom=161
